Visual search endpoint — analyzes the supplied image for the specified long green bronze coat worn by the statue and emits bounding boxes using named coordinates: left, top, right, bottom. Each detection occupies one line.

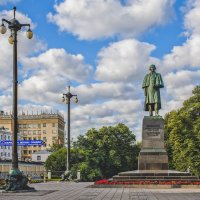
left=142, top=72, right=164, bottom=111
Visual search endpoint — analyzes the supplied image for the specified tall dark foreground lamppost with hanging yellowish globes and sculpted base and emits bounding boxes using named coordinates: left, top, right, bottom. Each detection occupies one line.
left=0, top=7, right=33, bottom=190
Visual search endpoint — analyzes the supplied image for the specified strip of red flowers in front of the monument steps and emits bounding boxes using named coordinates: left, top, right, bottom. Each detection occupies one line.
left=95, top=179, right=200, bottom=185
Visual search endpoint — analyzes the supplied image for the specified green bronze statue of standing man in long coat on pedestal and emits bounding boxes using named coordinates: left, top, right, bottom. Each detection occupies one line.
left=142, top=65, right=164, bottom=116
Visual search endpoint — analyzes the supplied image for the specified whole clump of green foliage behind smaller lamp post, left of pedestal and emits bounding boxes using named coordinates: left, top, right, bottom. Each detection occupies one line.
left=45, top=123, right=140, bottom=181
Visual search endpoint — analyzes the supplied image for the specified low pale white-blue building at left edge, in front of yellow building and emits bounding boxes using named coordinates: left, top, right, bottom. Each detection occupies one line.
left=0, top=127, right=21, bottom=160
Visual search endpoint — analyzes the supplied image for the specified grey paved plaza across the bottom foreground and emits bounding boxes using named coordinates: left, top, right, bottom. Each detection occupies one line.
left=0, top=182, right=200, bottom=200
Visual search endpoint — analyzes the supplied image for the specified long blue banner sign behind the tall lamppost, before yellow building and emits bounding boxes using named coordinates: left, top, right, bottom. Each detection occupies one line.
left=0, top=140, right=45, bottom=146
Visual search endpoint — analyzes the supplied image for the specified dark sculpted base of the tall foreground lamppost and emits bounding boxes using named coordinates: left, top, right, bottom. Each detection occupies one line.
left=4, top=169, right=34, bottom=191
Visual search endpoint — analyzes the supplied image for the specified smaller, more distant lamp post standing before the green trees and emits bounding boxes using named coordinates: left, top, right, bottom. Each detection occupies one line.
left=63, top=86, right=78, bottom=173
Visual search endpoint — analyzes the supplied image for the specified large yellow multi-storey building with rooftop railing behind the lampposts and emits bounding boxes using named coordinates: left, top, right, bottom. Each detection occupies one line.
left=0, top=112, right=65, bottom=161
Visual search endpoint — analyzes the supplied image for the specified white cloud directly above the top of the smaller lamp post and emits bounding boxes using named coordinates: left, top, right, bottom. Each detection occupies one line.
left=22, top=49, right=93, bottom=82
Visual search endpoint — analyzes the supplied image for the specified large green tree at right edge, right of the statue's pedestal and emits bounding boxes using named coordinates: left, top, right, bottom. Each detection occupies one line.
left=165, top=86, right=200, bottom=175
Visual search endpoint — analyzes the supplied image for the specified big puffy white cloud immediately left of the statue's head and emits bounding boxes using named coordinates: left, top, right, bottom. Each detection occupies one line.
left=96, top=39, right=159, bottom=82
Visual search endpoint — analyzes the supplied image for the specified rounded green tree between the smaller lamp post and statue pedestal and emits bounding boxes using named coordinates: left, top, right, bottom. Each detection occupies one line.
left=72, top=123, right=140, bottom=181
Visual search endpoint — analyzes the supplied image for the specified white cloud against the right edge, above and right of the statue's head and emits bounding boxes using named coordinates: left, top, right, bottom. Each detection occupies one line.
left=163, top=0, right=200, bottom=72
